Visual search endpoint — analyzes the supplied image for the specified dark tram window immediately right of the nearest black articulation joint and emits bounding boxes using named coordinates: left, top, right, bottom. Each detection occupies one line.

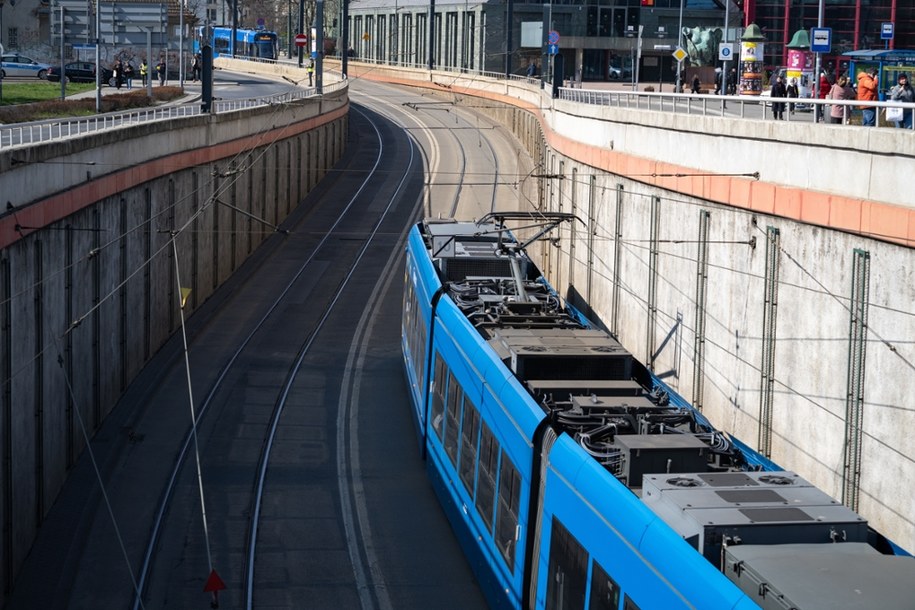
left=546, top=517, right=588, bottom=610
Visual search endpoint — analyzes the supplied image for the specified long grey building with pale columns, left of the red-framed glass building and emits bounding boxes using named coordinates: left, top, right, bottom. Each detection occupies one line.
left=348, top=0, right=741, bottom=83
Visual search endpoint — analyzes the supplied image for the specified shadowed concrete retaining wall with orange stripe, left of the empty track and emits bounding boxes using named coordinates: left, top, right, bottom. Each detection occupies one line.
left=0, top=89, right=348, bottom=592
